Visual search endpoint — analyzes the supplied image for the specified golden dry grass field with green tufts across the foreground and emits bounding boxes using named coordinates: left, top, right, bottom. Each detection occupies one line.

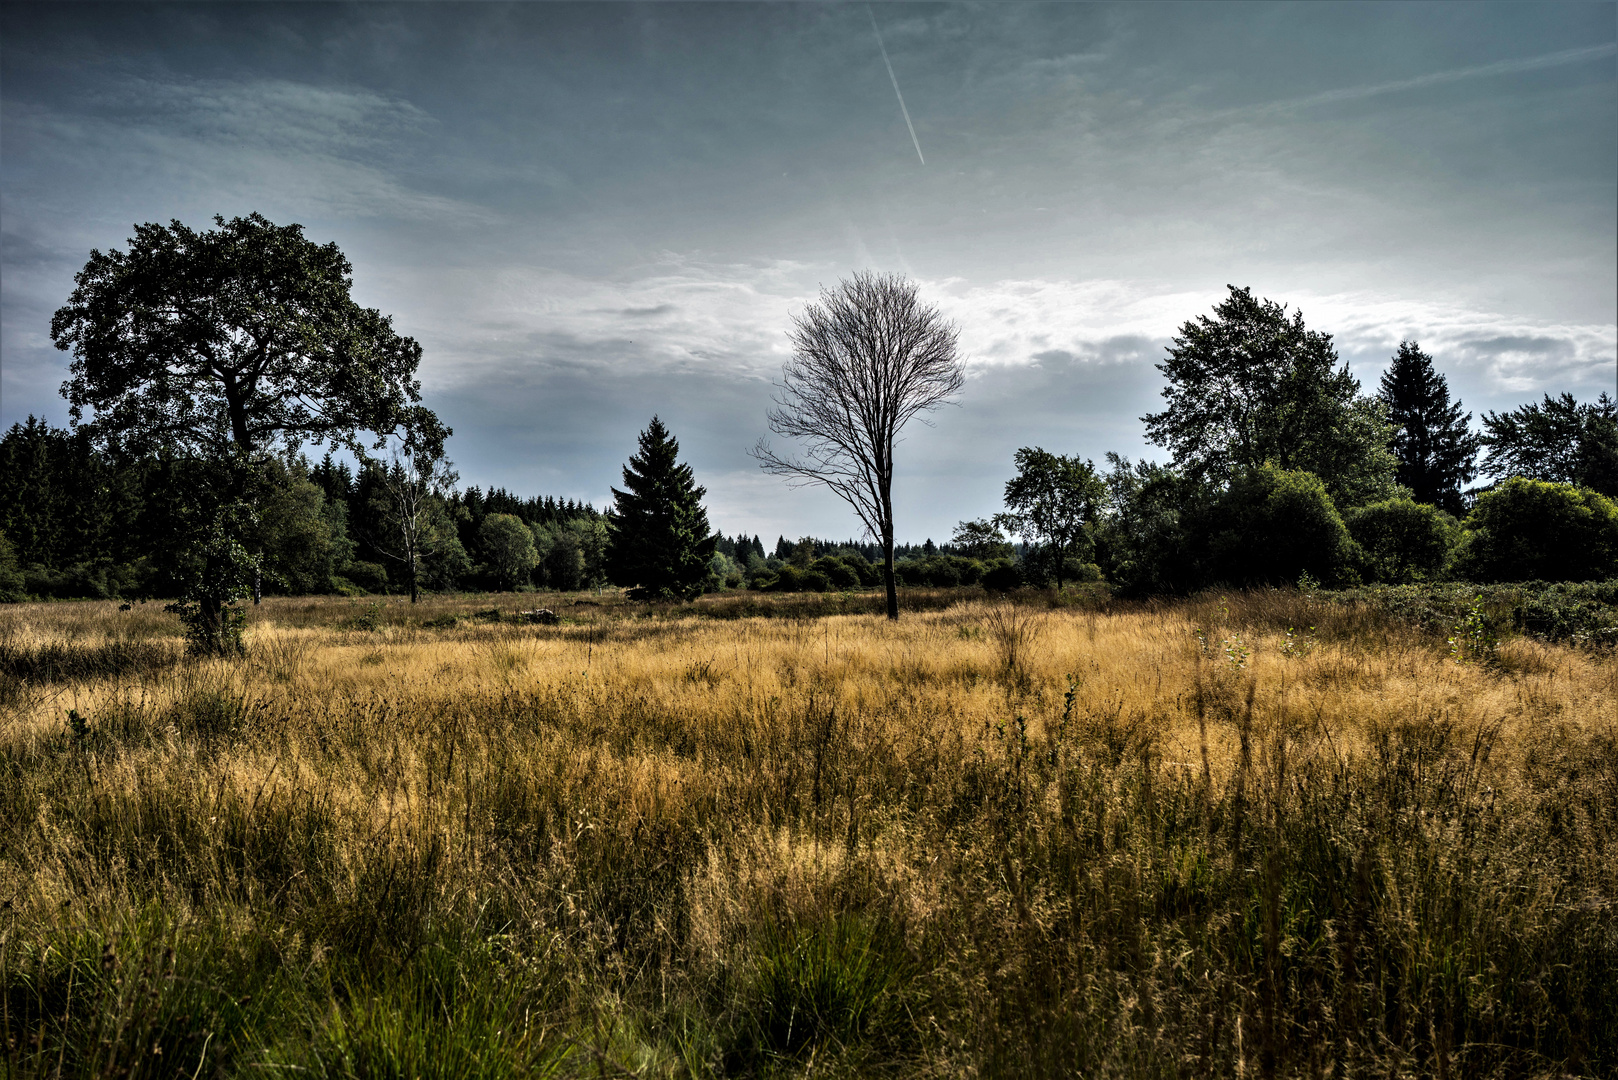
left=0, top=591, right=1618, bottom=1078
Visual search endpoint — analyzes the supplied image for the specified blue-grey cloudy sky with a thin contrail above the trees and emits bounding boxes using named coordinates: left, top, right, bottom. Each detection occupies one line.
left=0, top=3, right=1618, bottom=546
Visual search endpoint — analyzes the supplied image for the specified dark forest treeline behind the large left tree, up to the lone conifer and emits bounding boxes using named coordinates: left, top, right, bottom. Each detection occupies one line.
left=0, top=416, right=605, bottom=599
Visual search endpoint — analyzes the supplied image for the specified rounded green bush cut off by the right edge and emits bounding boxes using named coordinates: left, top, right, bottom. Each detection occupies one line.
left=1455, top=478, right=1618, bottom=581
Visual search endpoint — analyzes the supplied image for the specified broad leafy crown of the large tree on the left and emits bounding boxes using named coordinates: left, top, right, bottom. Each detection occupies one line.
left=50, top=214, right=450, bottom=458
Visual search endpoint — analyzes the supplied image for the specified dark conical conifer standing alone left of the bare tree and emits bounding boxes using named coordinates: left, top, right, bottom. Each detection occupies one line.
left=607, top=416, right=717, bottom=599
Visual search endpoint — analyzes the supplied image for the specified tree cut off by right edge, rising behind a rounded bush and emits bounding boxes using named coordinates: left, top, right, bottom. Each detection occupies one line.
left=1484, top=393, right=1618, bottom=497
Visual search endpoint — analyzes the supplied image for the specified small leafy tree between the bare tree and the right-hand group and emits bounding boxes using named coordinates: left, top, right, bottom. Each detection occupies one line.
left=995, top=447, right=1107, bottom=591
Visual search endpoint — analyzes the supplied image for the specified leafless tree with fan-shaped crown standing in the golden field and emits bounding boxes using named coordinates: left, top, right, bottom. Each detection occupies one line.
left=752, top=272, right=966, bottom=619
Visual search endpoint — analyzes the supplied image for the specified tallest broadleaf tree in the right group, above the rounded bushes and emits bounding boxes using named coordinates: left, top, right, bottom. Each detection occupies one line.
left=1141, top=285, right=1396, bottom=505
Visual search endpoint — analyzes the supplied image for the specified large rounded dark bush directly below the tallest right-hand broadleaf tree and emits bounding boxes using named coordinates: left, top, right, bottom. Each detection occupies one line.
left=1207, top=465, right=1353, bottom=585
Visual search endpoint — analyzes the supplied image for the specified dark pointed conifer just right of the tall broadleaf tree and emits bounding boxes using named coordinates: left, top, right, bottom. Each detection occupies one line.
left=1377, top=342, right=1484, bottom=513
